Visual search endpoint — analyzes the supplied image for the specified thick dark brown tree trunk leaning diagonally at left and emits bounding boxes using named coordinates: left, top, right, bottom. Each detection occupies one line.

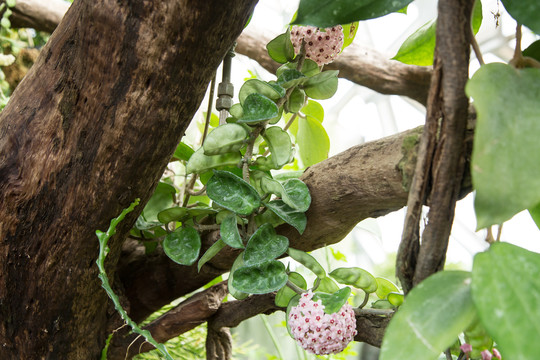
left=0, top=0, right=256, bottom=359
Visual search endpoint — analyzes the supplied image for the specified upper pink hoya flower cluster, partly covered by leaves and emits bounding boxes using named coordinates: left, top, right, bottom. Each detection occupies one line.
left=291, top=25, right=343, bottom=66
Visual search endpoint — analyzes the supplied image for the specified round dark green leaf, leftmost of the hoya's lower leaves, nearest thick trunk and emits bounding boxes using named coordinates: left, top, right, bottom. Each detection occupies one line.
left=163, top=227, right=201, bottom=266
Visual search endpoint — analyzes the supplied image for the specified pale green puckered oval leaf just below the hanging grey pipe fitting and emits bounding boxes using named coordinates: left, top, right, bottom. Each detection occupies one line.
left=203, top=124, right=249, bottom=156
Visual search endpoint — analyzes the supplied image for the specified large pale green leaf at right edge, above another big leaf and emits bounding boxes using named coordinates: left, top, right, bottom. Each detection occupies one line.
left=466, top=63, right=540, bottom=229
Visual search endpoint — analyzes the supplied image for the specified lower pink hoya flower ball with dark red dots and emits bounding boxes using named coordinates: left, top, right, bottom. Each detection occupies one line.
left=288, top=290, right=357, bottom=355
